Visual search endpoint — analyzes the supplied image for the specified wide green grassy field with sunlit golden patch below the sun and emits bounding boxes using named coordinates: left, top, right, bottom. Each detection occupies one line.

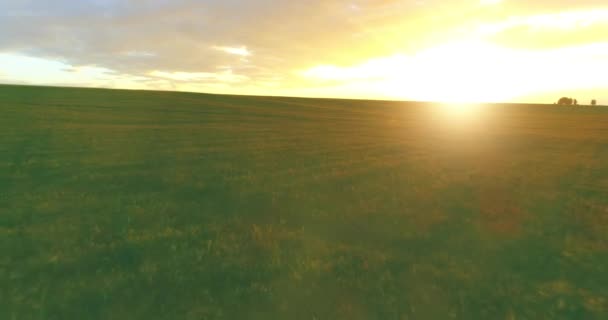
left=0, top=86, right=608, bottom=320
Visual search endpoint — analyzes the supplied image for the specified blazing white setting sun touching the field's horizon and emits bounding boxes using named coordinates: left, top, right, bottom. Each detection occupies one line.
left=382, top=41, right=516, bottom=102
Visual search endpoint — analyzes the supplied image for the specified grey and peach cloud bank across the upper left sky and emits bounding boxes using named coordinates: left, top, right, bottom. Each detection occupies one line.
left=0, top=0, right=428, bottom=80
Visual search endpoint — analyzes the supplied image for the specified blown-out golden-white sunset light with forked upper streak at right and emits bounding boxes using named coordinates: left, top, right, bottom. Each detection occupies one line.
left=300, top=7, right=608, bottom=103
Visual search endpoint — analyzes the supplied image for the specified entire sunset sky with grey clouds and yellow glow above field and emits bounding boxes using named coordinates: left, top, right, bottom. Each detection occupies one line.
left=0, top=0, right=608, bottom=104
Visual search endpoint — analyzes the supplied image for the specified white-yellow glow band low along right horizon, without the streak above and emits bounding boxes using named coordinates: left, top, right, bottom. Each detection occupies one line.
left=302, top=41, right=608, bottom=102
